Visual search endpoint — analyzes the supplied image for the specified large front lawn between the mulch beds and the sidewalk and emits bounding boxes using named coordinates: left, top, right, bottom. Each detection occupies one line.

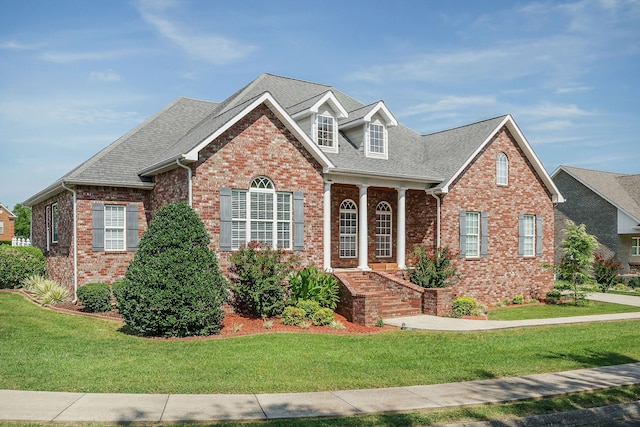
left=0, top=293, right=640, bottom=393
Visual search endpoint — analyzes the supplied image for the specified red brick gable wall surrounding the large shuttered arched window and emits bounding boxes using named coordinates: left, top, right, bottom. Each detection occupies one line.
left=192, top=106, right=324, bottom=272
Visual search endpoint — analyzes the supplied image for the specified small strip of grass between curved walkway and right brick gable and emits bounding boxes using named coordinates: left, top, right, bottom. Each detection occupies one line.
left=489, top=301, right=640, bottom=320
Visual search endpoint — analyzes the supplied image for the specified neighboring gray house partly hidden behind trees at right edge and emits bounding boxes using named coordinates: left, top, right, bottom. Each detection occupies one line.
left=552, top=166, right=640, bottom=273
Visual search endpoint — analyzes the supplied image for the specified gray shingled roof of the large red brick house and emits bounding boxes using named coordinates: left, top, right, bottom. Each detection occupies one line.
left=25, top=74, right=544, bottom=204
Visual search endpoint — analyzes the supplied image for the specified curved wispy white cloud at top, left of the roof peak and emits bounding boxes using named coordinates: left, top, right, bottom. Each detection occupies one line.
left=138, top=1, right=256, bottom=65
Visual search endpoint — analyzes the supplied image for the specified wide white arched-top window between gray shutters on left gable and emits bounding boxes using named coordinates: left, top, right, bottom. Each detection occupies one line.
left=231, top=176, right=291, bottom=249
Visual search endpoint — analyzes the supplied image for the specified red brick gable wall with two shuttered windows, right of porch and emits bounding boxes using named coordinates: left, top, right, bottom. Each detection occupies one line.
left=441, top=129, right=554, bottom=304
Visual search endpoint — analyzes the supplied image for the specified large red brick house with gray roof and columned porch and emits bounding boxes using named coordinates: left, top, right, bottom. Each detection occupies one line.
left=25, top=74, right=562, bottom=323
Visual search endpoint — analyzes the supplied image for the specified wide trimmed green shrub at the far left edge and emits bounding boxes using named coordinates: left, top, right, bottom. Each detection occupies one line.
left=0, top=245, right=47, bottom=289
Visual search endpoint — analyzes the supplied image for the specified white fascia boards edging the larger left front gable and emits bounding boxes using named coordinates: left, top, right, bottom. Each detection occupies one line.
left=182, top=92, right=334, bottom=168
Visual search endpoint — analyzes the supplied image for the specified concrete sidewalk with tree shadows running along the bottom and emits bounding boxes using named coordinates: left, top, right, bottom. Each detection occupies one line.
left=0, top=363, right=640, bottom=423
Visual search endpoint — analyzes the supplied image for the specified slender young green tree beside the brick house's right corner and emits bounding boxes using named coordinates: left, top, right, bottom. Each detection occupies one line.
left=558, top=220, right=598, bottom=305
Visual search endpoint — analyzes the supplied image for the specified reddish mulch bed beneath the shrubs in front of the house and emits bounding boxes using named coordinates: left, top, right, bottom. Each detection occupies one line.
left=7, top=290, right=397, bottom=339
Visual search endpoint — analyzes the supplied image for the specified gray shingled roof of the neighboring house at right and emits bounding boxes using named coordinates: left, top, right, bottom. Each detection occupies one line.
left=560, top=165, right=640, bottom=222
